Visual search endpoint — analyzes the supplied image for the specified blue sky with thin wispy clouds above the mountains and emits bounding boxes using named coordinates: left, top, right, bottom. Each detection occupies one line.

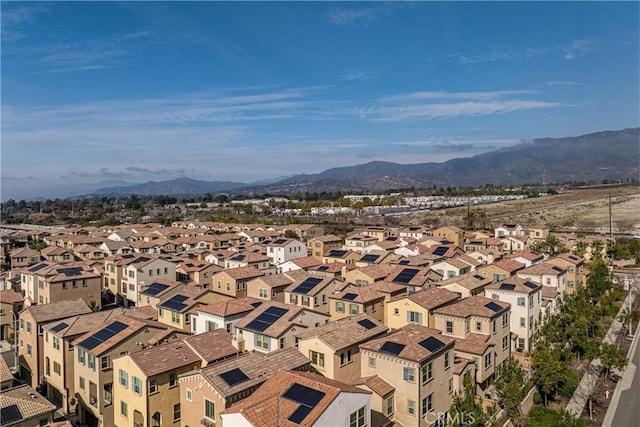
left=0, top=2, right=640, bottom=200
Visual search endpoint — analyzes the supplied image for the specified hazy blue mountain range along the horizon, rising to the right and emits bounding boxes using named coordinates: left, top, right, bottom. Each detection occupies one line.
left=93, top=128, right=640, bottom=196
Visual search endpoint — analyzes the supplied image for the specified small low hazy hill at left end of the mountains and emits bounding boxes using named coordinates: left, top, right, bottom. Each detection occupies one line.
left=93, top=178, right=247, bottom=196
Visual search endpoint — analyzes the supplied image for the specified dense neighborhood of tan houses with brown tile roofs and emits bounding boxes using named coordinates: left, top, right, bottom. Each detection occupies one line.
left=0, top=217, right=636, bottom=427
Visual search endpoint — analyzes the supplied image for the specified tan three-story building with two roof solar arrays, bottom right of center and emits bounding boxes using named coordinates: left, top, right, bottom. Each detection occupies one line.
left=360, top=324, right=455, bottom=426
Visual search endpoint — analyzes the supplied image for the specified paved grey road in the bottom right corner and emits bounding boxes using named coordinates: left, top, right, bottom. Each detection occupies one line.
left=602, top=332, right=640, bottom=427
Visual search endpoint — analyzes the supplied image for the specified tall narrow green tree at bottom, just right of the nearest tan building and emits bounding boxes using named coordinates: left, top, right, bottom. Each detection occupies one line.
left=494, top=357, right=528, bottom=426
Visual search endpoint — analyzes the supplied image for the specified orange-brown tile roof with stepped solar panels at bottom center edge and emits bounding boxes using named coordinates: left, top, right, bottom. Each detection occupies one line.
left=222, top=371, right=371, bottom=427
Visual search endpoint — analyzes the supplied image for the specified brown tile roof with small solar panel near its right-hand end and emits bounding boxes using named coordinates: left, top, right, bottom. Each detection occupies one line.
left=295, top=313, right=387, bottom=351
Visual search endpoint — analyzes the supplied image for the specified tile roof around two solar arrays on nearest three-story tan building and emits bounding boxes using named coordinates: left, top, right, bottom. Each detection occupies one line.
left=360, top=324, right=455, bottom=362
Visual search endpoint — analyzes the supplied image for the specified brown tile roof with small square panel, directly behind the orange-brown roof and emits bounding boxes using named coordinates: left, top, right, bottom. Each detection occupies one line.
left=190, top=347, right=311, bottom=398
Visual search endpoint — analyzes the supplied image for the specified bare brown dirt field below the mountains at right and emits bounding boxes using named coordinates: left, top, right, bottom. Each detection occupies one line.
left=411, top=187, right=640, bottom=234
